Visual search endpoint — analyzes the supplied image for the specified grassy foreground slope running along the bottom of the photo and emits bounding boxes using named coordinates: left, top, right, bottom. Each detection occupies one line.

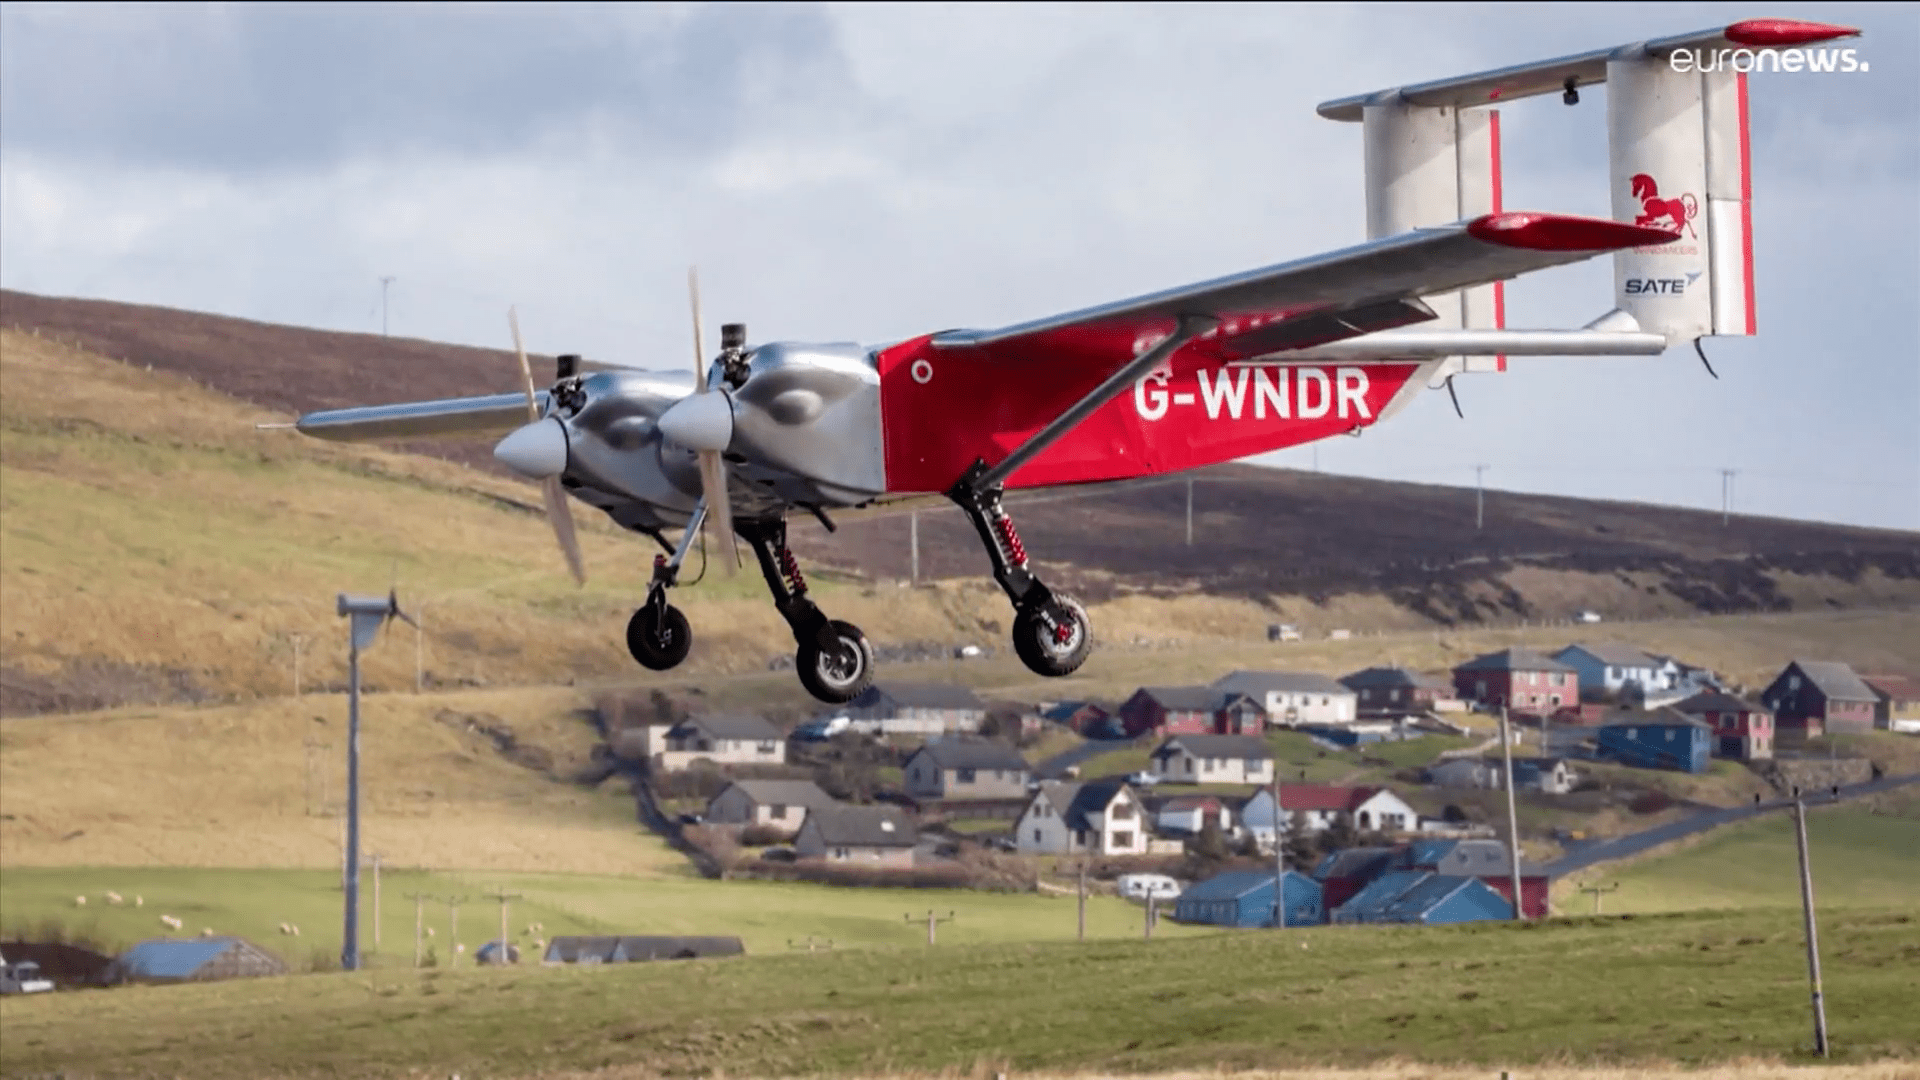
left=0, top=909, right=1920, bottom=1080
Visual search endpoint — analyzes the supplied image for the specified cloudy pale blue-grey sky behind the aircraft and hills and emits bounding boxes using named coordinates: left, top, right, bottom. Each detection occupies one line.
left=0, top=4, right=1920, bottom=528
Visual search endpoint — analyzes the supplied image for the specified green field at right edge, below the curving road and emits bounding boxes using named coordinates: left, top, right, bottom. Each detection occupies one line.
left=1555, top=805, right=1920, bottom=913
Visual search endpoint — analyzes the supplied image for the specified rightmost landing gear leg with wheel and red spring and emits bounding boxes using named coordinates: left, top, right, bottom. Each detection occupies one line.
left=947, top=461, right=1092, bottom=678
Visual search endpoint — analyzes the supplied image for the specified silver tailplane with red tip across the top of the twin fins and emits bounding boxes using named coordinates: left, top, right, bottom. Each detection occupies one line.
left=1319, top=19, right=1860, bottom=123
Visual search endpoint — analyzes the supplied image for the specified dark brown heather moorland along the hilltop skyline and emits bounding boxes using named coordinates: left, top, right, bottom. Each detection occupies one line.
left=0, top=292, right=1920, bottom=625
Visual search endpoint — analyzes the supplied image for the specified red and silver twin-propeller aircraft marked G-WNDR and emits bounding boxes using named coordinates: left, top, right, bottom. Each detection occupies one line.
left=298, top=19, right=1859, bottom=703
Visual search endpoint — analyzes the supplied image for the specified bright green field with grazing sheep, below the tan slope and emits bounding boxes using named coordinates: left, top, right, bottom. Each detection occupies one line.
left=0, top=867, right=1196, bottom=970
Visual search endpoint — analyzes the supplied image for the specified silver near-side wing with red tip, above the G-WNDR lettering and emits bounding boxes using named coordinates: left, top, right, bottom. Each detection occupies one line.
left=929, top=213, right=1678, bottom=369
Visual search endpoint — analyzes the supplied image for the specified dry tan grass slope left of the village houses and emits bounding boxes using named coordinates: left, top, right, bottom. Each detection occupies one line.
left=0, top=688, right=684, bottom=872
